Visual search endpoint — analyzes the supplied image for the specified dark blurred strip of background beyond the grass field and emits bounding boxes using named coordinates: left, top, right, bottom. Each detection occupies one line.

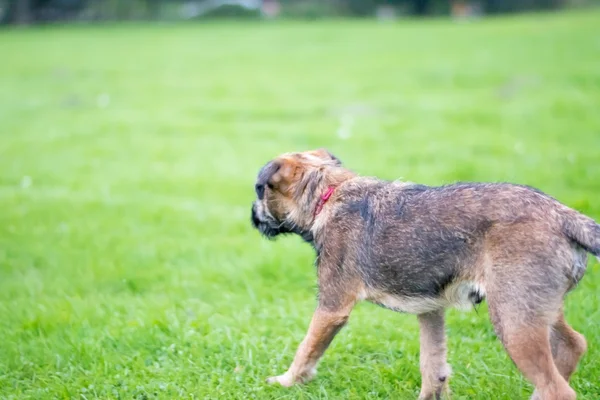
left=0, top=0, right=596, bottom=24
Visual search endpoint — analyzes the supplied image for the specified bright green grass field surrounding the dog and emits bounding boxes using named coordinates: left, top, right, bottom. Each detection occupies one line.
left=0, top=11, right=600, bottom=399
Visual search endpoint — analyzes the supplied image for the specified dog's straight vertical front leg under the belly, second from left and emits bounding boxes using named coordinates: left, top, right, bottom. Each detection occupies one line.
left=418, top=310, right=450, bottom=400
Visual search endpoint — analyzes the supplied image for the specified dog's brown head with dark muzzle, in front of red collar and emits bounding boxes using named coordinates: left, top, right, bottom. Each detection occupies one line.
left=252, top=149, right=343, bottom=241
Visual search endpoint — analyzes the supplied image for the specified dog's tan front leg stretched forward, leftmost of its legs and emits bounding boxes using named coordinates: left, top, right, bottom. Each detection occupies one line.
left=267, top=306, right=352, bottom=387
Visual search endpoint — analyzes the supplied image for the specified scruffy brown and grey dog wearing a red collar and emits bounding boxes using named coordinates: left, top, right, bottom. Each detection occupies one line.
left=252, top=150, right=600, bottom=400
